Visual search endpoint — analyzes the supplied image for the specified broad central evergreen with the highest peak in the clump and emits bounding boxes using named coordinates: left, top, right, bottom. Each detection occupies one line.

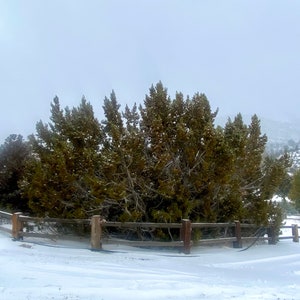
left=141, top=83, right=231, bottom=222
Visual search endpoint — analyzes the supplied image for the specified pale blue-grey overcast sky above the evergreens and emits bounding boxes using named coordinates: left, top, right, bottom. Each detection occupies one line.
left=0, top=0, right=300, bottom=143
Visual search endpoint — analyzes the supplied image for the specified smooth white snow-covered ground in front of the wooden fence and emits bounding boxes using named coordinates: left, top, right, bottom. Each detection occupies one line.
left=0, top=219, right=300, bottom=300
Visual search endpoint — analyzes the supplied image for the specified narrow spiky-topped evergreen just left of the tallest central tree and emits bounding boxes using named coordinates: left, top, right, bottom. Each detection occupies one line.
left=101, top=91, right=147, bottom=221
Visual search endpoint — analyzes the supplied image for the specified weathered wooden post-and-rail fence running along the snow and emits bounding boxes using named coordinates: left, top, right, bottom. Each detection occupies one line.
left=0, top=211, right=299, bottom=254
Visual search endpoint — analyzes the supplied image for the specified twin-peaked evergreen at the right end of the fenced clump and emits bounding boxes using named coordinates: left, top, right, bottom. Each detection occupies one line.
left=225, top=114, right=289, bottom=225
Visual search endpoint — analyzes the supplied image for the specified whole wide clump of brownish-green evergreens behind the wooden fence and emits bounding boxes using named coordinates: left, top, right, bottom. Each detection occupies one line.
left=0, top=82, right=289, bottom=224
